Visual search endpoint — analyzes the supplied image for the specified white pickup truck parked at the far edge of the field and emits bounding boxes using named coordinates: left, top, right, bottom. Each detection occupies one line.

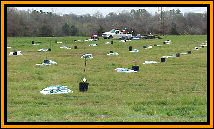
left=102, top=29, right=132, bottom=39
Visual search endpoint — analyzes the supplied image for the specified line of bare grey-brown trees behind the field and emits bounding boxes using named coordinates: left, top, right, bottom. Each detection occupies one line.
left=7, top=7, right=207, bottom=37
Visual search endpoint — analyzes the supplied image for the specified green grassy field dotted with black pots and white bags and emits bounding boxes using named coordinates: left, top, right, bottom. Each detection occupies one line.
left=7, top=35, right=207, bottom=122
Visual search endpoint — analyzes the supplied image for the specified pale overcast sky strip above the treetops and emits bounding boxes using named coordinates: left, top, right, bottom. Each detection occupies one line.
left=16, top=7, right=207, bottom=16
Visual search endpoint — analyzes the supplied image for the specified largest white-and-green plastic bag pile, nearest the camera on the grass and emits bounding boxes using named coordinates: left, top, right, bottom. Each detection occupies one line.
left=40, top=85, right=73, bottom=95
